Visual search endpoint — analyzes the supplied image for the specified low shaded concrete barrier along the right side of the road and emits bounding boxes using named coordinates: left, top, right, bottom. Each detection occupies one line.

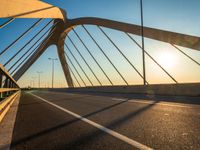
left=63, top=83, right=200, bottom=96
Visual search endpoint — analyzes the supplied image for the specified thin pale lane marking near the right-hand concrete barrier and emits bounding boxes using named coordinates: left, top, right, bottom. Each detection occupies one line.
left=112, top=98, right=198, bottom=108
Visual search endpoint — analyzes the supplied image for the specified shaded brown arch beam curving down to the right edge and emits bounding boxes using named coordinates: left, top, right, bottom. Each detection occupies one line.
left=66, top=17, right=200, bottom=51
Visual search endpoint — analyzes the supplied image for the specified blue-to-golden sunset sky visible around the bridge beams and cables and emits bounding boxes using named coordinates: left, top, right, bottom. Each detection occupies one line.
left=0, top=0, right=200, bottom=87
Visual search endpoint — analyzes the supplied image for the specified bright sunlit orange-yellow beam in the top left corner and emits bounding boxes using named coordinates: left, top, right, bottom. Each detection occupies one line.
left=0, top=0, right=65, bottom=20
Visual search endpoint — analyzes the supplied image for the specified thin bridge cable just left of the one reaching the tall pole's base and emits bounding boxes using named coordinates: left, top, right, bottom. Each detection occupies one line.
left=82, top=25, right=128, bottom=85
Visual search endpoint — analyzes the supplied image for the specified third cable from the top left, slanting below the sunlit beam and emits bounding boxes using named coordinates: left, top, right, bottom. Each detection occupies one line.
left=4, top=20, right=53, bottom=67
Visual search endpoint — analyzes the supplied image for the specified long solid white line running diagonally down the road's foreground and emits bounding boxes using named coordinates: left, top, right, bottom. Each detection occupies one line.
left=29, top=93, right=152, bottom=150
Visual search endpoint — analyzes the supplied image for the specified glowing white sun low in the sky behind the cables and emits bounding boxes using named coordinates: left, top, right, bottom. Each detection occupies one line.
left=158, top=52, right=176, bottom=69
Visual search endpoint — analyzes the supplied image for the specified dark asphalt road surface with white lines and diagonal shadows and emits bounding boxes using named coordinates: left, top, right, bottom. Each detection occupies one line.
left=11, top=91, right=200, bottom=150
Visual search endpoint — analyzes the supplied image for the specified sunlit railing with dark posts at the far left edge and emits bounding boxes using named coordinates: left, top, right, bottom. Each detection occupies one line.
left=0, top=64, right=20, bottom=102
